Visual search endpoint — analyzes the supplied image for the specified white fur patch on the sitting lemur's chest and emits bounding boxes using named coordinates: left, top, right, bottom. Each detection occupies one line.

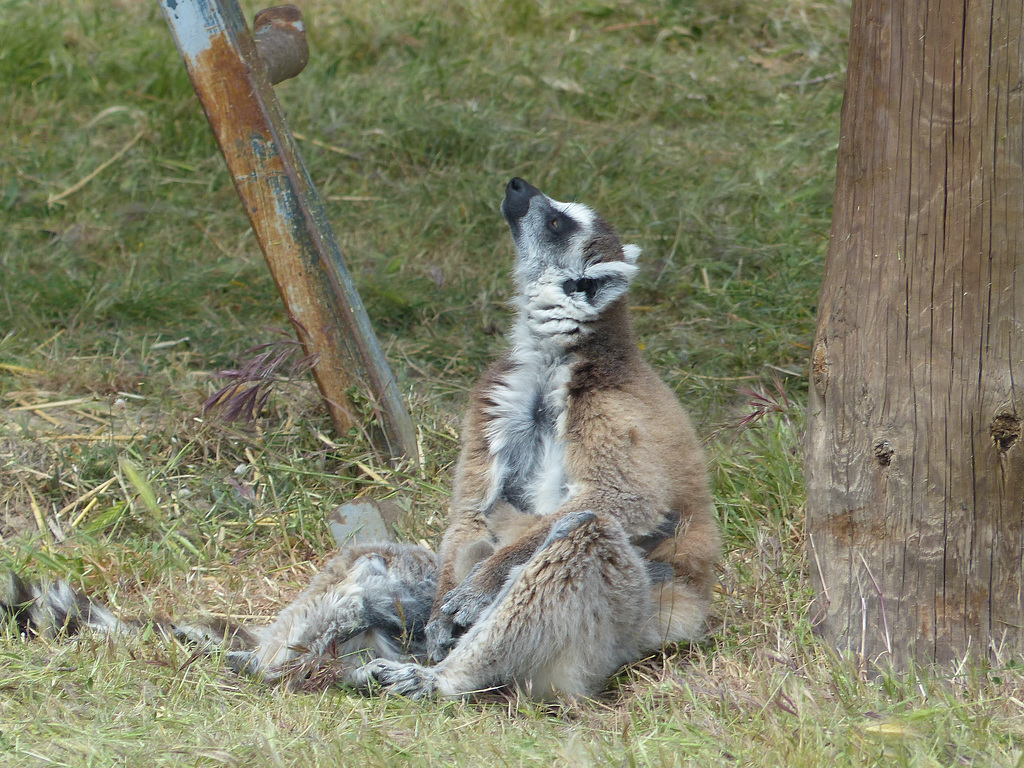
left=484, top=351, right=572, bottom=515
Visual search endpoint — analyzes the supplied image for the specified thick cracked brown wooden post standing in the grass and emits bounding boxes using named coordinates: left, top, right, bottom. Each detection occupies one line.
left=806, top=0, right=1024, bottom=669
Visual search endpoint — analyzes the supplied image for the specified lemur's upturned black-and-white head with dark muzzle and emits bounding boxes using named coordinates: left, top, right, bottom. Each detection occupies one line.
left=502, top=178, right=640, bottom=344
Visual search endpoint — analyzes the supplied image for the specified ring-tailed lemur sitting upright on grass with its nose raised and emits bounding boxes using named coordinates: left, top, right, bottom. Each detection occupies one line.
left=0, top=178, right=720, bottom=698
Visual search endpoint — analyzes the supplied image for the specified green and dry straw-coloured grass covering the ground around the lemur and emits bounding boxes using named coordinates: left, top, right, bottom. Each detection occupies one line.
left=0, top=0, right=1024, bottom=766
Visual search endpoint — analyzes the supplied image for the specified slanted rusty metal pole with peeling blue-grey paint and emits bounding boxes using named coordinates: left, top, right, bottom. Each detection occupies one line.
left=160, top=0, right=418, bottom=461
